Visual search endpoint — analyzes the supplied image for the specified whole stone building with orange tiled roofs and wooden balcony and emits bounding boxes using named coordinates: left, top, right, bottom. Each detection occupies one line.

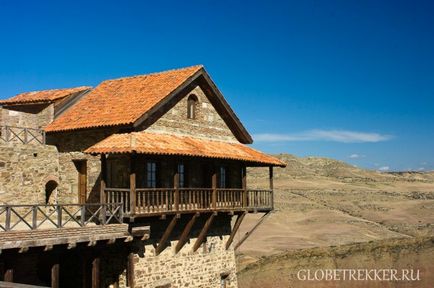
left=0, top=66, right=285, bottom=287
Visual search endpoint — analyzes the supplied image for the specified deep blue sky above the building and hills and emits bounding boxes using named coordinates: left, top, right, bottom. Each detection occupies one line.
left=0, top=0, right=434, bottom=170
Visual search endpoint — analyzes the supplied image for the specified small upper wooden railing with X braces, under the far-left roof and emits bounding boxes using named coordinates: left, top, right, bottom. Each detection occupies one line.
left=0, top=126, right=45, bottom=144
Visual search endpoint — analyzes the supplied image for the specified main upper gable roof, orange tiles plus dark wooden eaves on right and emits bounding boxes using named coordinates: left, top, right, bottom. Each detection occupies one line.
left=45, top=65, right=252, bottom=143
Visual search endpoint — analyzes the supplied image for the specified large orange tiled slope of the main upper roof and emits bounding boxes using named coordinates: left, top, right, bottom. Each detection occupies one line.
left=45, top=66, right=202, bottom=132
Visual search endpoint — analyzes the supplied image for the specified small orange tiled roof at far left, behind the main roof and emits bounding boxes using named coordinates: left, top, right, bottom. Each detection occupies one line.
left=0, top=86, right=92, bottom=105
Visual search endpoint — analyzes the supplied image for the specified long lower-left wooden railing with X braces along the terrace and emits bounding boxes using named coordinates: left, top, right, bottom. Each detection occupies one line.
left=0, top=203, right=123, bottom=231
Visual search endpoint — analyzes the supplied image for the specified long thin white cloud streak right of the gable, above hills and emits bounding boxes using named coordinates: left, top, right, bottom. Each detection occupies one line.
left=253, top=129, right=392, bottom=143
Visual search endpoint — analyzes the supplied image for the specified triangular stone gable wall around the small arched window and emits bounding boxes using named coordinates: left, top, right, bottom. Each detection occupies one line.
left=146, top=86, right=238, bottom=142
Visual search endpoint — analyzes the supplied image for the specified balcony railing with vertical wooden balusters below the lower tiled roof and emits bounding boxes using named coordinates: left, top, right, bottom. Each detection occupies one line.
left=104, top=188, right=273, bottom=215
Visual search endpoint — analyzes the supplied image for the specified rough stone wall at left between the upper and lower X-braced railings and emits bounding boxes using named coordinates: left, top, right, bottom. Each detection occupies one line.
left=0, top=143, right=60, bottom=204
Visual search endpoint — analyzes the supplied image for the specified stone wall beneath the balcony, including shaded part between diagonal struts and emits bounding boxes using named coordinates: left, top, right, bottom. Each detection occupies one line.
left=120, top=214, right=237, bottom=288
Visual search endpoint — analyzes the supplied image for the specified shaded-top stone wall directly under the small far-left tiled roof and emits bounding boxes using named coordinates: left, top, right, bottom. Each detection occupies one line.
left=0, top=104, right=54, bottom=129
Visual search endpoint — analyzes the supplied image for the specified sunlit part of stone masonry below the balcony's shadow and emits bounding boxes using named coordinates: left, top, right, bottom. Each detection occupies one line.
left=134, top=236, right=238, bottom=288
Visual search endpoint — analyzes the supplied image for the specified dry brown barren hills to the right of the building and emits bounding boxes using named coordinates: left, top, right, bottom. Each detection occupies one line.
left=235, top=154, right=434, bottom=287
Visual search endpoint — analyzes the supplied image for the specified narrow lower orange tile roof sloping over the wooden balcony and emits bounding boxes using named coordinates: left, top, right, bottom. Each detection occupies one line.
left=85, top=132, right=286, bottom=167
